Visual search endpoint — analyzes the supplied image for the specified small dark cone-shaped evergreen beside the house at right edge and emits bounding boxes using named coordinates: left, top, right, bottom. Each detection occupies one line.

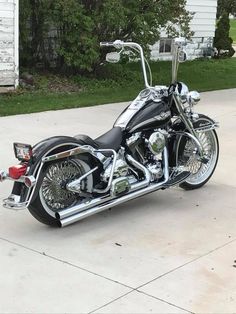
left=214, top=12, right=235, bottom=57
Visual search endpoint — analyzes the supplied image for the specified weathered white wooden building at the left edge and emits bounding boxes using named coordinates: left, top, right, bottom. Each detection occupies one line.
left=0, top=0, right=19, bottom=87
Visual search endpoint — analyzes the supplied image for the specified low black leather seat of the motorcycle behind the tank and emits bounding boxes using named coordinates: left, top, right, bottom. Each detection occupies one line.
left=75, top=127, right=122, bottom=151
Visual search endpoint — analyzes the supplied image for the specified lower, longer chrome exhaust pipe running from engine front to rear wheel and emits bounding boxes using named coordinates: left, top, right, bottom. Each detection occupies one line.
left=58, top=148, right=169, bottom=227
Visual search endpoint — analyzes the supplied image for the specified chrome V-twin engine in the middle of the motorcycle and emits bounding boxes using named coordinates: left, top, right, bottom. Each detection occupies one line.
left=100, top=129, right=166, bottom=196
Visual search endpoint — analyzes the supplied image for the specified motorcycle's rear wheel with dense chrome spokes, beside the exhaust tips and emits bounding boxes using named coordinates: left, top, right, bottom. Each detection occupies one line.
left=29, top=158, right=93, bottom=226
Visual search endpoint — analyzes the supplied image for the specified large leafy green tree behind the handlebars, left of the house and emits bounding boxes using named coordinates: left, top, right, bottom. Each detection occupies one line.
left=20, top=0, right=192, bottom=71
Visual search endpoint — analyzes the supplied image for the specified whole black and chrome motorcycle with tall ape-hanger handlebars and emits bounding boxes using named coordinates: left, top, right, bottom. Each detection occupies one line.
left=0, top=38, right=219, bottom=227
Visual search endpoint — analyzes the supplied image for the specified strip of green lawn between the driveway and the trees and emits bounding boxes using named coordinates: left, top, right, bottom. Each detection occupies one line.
left=0, top=58, right=236, bottom=116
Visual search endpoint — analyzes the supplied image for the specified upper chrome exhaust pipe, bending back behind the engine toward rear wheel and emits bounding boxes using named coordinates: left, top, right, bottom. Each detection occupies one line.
left=56, top=155, right=151, bottom=220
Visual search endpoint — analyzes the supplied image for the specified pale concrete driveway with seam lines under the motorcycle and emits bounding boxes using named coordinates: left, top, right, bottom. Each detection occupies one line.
left=0, top=90, right=236, bottom=314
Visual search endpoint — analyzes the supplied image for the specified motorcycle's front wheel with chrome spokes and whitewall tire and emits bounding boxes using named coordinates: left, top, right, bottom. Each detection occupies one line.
left=178, top=121, right=219, bottom=190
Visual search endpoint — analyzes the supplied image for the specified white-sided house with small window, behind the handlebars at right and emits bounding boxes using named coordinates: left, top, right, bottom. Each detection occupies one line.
left=151, top=0, right=217, bottom=60
